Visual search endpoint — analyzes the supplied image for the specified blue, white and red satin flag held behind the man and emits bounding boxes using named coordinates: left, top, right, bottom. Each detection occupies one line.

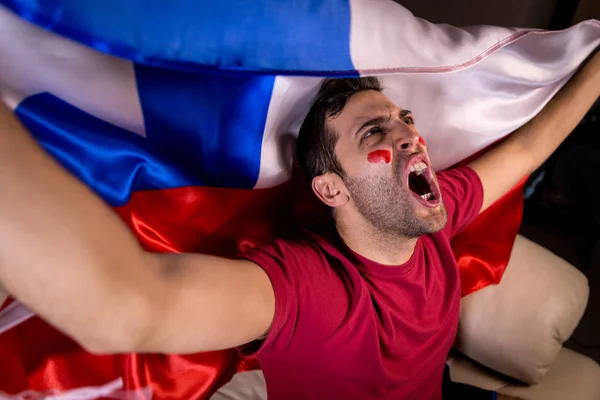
left=0, top=0, right=600, bottom=399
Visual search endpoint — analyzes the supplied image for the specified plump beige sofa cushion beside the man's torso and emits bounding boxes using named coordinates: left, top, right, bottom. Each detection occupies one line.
left=455, top=236, right=589, bottom=383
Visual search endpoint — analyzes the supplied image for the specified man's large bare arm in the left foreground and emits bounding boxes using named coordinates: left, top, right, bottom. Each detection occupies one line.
left=0, top=103, right=274, bottom=353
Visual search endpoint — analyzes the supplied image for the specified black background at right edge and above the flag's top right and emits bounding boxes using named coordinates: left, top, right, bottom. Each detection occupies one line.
left=396, top=0, right=600, bottom=362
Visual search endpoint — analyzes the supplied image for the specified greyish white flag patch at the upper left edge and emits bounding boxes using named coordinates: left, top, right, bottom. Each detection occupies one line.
left=0, top=6, right=145, bottom=136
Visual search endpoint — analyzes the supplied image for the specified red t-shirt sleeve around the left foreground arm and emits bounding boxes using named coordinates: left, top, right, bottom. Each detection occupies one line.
left=236, top=240, right=326, bottom=356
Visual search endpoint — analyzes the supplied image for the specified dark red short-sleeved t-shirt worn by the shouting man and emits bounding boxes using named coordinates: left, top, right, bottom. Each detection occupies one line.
left=241, top=167, right=483, bottom=400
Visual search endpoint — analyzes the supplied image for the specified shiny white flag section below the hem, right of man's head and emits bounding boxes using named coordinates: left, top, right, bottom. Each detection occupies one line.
left=383, top=21, right=600, bottom=170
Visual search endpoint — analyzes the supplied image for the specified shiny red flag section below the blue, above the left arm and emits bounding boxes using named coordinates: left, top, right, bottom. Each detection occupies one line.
left=115, top=183, right=300, bottom=253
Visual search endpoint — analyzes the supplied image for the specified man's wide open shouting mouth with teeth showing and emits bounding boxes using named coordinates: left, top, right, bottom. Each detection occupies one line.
left=406, top=154, right=441, bottom=207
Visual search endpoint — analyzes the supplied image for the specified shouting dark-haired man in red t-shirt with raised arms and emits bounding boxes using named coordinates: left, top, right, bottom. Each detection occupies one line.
left=0, top=48, right=600, bottom=400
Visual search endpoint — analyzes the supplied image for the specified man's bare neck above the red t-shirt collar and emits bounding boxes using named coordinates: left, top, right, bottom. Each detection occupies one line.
left=336, top=219, right=418, bottom=266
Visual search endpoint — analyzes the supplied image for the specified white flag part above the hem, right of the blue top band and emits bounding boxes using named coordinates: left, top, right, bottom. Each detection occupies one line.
left=350, top=0, right=525, bottom=75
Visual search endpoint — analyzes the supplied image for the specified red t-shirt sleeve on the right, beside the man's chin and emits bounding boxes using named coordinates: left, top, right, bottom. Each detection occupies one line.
left=437, top=166, right=483, bottom=237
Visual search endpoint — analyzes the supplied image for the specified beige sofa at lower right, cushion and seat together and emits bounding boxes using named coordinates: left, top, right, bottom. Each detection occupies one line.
left=448, top=236, right=600, bottom=400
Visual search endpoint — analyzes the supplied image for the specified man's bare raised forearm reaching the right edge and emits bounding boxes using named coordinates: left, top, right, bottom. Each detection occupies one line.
left=469, top=52, right=600, bottom=211
